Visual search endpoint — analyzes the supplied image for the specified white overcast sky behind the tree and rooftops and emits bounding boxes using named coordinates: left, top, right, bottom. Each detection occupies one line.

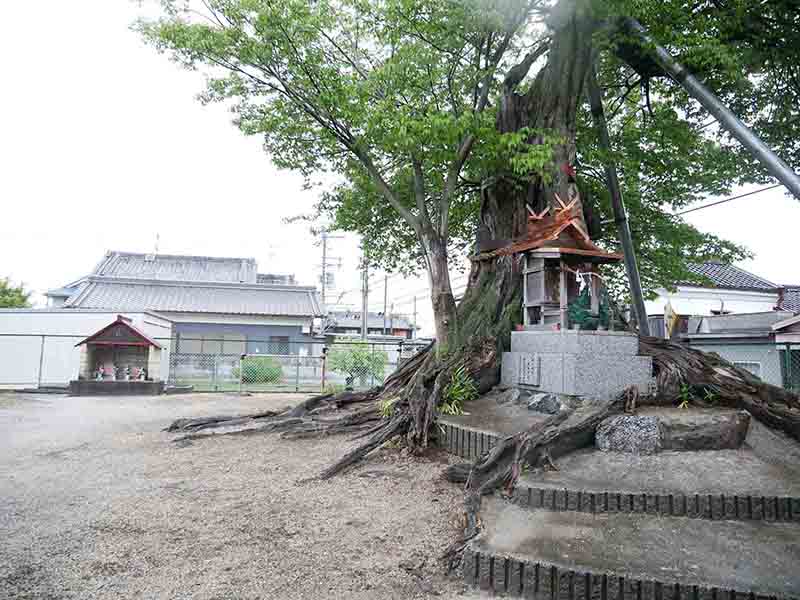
left=0, top=0, right=800, bottom=328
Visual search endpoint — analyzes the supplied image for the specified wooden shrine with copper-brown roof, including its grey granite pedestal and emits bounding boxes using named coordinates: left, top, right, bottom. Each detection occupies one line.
left=476, top=182, right=652, bottom=398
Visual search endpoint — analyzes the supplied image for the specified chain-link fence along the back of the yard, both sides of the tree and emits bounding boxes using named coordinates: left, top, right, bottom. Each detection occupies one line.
left=12, top=334, right=800, bottom=393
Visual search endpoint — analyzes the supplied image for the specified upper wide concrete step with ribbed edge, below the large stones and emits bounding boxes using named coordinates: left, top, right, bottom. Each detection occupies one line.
left=513, top=447, right=800, bottom=523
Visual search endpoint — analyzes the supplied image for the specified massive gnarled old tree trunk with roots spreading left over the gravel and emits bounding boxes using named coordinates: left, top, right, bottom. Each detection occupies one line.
left=162, top=1, right=591, bottom=477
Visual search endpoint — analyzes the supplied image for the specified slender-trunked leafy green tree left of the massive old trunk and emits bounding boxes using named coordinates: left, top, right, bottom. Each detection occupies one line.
left=140, top=0, right=564, bottom=344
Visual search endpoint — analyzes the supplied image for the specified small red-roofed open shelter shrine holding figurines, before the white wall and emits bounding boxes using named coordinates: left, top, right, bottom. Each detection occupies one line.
left=70, top=315, right=164, bottom=396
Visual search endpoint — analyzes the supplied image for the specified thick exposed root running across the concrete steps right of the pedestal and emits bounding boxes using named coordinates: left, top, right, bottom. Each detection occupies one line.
left=444, top=337, right=800, bottom=569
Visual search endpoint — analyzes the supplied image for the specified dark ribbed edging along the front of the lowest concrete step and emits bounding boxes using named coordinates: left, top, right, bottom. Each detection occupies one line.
left=462, top=547, right=797, bottom=600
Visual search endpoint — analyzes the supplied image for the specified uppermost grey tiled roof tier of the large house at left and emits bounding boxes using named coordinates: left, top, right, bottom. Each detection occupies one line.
left=92, top=252, right=257, bottom=283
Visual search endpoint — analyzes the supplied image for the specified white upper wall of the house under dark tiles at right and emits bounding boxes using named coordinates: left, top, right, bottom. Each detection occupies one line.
left=645, top=286, right=778, bottom=316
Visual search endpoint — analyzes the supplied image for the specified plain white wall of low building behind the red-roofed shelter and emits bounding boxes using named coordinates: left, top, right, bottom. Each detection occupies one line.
left=0, top=309, right=172, bottom=389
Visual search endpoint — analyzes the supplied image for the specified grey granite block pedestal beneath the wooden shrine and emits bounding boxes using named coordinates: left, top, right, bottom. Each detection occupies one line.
left=501, top=330, right=653, bottom=398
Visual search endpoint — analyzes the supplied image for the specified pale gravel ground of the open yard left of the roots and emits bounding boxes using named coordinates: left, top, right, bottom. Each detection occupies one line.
left=0, top=394, right=479, bottom=599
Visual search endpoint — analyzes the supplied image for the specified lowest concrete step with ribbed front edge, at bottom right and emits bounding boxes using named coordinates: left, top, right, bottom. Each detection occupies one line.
left=463, top=497, right=800, bottom=600
